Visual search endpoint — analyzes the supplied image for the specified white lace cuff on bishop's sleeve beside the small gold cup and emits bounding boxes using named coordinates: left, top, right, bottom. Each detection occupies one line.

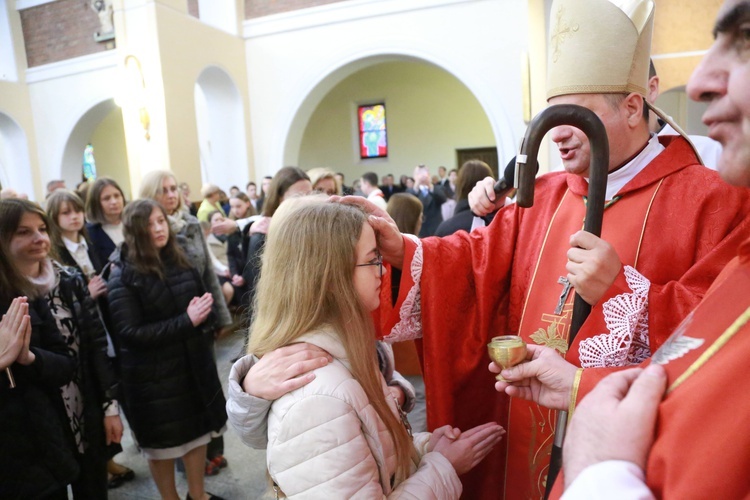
left=578, top=266, right=651, bottom=368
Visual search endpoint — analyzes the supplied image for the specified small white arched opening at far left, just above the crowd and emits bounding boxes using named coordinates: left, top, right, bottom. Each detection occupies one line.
left=0, top=113, right=34, bottom=199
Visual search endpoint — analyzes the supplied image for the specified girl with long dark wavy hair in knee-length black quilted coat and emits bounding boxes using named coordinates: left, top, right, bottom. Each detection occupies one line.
left=108, top=199, right=227, bottom=499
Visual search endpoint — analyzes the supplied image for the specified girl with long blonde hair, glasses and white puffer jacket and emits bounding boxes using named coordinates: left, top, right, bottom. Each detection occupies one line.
left=248, top=203, right=503, bottom=499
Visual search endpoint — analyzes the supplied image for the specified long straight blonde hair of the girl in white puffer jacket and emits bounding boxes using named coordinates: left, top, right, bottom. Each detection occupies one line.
left=248, top=198, right=413, bottom=482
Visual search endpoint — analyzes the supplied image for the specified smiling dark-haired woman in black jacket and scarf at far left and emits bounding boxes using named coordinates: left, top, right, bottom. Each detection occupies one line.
left=0, top=200, right=122, bottom=499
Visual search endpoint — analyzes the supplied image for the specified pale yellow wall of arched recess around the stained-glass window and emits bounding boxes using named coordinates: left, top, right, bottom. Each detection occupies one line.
left=294, top=57, right=504, bottom=179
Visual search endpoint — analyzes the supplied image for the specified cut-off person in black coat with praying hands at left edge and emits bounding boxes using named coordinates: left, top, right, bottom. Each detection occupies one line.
left=0, top=200, right=78, bottom=499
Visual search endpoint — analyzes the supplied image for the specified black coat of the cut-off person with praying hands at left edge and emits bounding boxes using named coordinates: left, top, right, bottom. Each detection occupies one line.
left=0, top=299, right=78, bottom=499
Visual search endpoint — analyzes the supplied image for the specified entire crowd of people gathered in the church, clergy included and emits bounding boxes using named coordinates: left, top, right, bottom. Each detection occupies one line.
left=0, top=0, right=750, bottom=499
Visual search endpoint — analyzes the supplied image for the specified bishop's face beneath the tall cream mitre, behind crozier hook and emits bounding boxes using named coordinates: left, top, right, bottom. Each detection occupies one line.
left=549, top=94, right=632, bottom=177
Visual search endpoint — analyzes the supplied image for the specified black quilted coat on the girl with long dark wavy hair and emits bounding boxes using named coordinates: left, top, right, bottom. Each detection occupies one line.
left=107, top=248, right=227, bottom=448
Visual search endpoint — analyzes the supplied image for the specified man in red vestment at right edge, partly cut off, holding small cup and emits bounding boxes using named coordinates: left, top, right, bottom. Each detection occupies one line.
left=492, top=0, right=750, bottom=499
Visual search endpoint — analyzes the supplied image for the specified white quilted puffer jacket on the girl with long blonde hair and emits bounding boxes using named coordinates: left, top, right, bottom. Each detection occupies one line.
left=266, top=331, right=461, bottom=500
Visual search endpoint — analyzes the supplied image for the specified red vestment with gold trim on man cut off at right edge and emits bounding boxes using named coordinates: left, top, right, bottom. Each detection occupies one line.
left=553, top=236, right=750, bottom=498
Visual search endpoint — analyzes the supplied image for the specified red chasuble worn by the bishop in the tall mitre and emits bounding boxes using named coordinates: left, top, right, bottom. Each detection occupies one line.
left=385, top=137, right=750, bottom=499
